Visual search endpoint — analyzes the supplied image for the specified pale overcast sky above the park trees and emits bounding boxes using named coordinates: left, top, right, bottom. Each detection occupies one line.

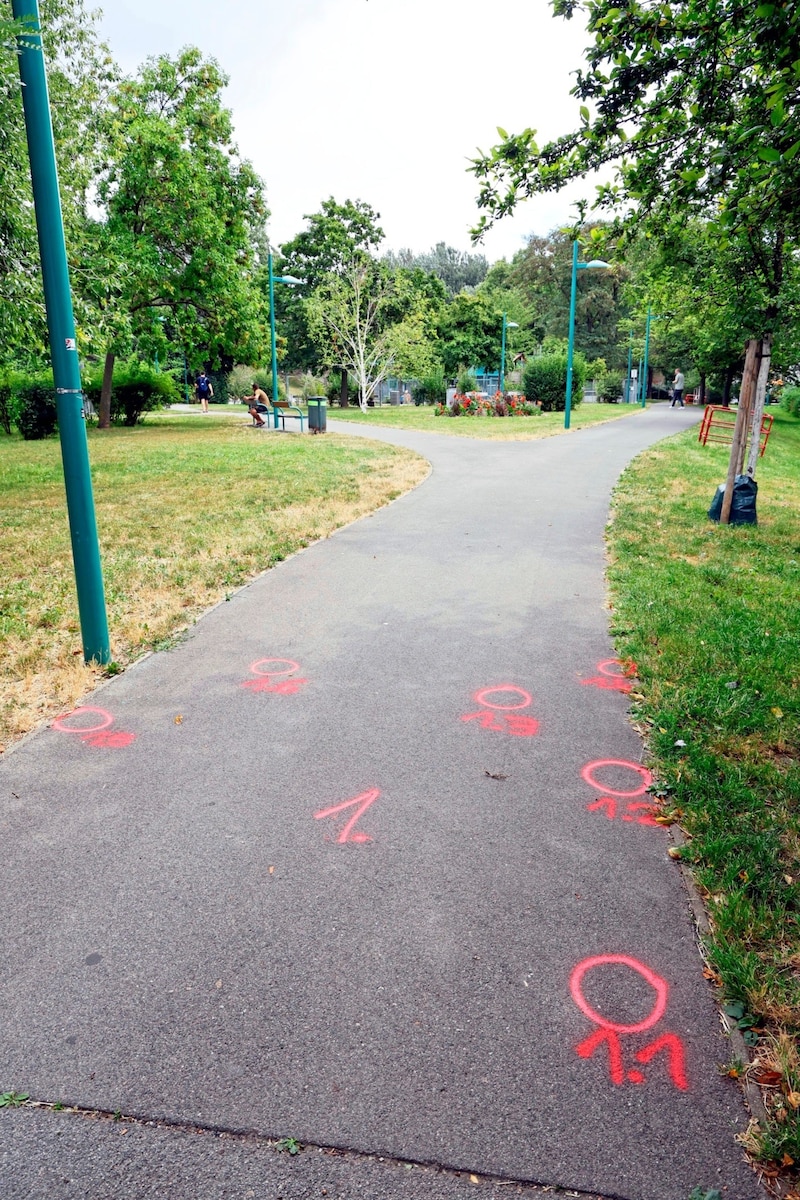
left=101, top=0, right=591, bottom=262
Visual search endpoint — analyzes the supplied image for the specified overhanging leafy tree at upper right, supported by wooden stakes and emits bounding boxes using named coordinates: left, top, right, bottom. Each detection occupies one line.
left=471, top=0, right=800, bottom=487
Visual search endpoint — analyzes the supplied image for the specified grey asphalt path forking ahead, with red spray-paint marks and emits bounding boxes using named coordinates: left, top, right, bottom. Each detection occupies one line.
left=0, top=406, right=760, bottom=1200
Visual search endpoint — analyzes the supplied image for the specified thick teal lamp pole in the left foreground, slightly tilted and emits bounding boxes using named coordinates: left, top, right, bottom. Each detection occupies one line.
left=11, top=0, right=112, bottom=664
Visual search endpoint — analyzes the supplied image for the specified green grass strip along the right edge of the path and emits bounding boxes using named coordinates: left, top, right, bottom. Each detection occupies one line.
left=608, top=410, right=800, bottom=1172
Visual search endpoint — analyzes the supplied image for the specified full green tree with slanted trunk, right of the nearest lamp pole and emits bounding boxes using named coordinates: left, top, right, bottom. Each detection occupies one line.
left=94, top=47, right=266, bottom=425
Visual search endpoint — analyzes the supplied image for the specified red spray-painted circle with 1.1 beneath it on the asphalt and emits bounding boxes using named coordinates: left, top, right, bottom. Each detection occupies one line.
left=570, top=954, right=688, bottom=1092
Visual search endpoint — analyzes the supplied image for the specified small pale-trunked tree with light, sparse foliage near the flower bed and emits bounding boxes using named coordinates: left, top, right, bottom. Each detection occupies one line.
left=308, top=259, right=393, bottom=410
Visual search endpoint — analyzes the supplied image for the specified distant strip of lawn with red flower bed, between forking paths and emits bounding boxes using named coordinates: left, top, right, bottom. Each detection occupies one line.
left=327, top=404, right=640, bottom=442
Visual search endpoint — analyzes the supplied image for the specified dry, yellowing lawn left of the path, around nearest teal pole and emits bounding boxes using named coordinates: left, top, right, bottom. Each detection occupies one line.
left=0, top=409, right=428, bottom=748
